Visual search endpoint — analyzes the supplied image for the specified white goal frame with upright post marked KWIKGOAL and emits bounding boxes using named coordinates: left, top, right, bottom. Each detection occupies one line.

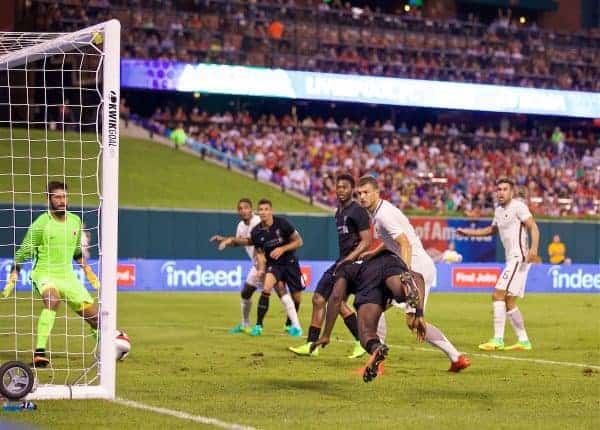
left=0, top=19, right=121, bottom=399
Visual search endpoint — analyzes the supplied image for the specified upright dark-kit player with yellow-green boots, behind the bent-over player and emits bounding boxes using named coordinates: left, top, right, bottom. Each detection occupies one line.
left=289, top=174, right=371, bottom=358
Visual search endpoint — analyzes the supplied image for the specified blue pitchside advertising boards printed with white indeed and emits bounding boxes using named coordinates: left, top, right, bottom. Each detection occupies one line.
left=0, top=259, right=600, bottom=293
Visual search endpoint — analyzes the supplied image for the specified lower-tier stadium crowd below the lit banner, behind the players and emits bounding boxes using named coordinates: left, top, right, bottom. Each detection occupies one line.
left=145, top=108, right=600, bottom=216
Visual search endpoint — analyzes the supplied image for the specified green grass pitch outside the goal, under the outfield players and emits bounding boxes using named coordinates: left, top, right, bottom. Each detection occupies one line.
left=0, top=293, right=600, bottom=430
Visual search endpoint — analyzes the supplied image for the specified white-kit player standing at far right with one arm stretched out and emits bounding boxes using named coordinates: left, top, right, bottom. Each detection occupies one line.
left=456, top=179, right=540, bottom=351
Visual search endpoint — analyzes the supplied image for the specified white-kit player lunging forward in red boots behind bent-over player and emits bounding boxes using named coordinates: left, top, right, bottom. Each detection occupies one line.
left=358, top=176, right=471, bottom=372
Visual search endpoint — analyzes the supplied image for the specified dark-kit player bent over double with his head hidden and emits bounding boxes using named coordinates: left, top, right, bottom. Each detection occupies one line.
left=311, top=250, right=428, bottom=382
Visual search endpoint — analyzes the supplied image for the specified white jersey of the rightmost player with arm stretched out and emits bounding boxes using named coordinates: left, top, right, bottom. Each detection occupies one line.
left=492, top=199, right=531, bottom=261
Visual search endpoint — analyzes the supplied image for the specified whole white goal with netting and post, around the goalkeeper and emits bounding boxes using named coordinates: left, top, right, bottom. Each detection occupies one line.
left=0, top=20, right=120, bottom=399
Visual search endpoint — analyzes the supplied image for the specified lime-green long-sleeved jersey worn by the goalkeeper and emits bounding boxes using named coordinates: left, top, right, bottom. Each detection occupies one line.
left=15, top=212, right=81, bottom=277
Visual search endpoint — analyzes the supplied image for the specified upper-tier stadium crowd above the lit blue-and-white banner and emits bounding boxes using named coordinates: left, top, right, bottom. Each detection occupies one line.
left=31, top=0, right=600, bottom=91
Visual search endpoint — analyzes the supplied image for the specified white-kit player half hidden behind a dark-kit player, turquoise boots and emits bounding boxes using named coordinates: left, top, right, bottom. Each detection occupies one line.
left=210, top=198, right=265, bottom=333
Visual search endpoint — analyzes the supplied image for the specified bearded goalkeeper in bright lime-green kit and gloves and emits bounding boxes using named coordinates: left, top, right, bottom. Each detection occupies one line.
left=2, top=182, right=100, bottom=367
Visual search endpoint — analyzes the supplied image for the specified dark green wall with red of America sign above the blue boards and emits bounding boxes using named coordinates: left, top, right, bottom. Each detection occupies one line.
left=0, top=205, right=600, bottom=264
